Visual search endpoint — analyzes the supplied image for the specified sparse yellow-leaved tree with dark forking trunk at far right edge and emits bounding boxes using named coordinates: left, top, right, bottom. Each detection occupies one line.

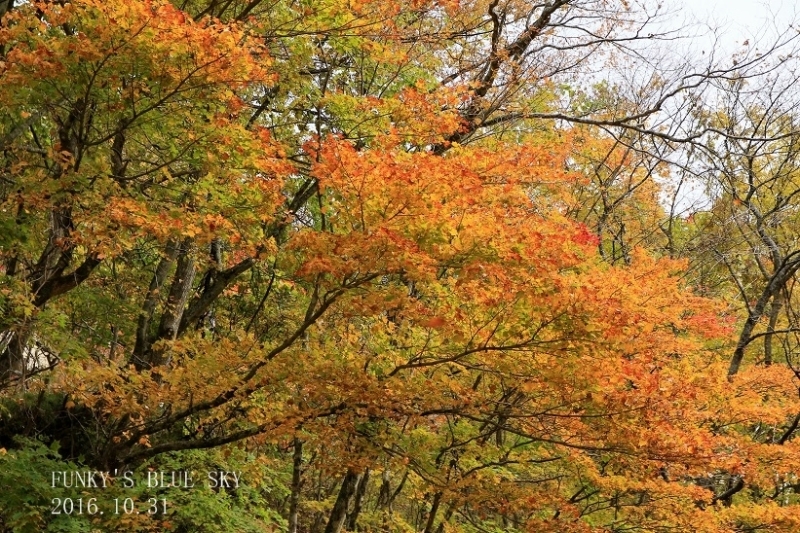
left=684, top=68, right=800, bottom=376
